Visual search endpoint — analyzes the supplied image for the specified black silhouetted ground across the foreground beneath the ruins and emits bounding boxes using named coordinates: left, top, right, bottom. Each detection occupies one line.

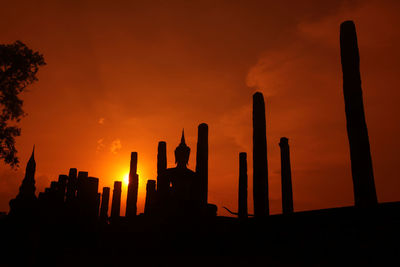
left=0, top=202, right=400, bottom=266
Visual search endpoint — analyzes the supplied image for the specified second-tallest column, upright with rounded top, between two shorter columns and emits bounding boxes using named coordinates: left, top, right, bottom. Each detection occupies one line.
left=253, top=92, right=269, bottom=217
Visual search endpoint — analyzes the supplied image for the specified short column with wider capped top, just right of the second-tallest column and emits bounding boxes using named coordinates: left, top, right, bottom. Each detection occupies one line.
left=279, top=137, right=293, bottom=214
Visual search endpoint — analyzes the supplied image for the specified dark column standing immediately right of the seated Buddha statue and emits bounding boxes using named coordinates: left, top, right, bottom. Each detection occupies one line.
left=196, top=123, right=208, bottom=205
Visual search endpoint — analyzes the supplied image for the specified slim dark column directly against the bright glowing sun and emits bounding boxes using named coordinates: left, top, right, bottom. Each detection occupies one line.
left=125, top=152, right=139, bottom=217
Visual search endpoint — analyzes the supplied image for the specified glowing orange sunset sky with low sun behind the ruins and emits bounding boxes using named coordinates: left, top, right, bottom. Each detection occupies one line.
left=0, top=0, right=400, bottom=218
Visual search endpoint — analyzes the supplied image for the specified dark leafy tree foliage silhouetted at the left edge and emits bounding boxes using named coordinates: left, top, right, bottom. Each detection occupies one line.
left=0, top=41, right=46, bottom=167
